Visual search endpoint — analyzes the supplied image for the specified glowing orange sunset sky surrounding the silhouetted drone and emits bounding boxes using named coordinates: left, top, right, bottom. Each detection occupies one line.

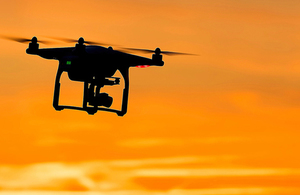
left=0, top=0, right=300, bottom=195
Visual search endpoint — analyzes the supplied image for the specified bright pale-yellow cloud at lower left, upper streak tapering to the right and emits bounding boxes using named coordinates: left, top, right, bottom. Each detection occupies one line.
left=0, top=156, right=213, bottom=191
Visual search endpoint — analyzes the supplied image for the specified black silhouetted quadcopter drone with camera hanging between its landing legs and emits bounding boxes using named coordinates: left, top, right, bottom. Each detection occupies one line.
left=4, top=37, right=190, bottom=116
